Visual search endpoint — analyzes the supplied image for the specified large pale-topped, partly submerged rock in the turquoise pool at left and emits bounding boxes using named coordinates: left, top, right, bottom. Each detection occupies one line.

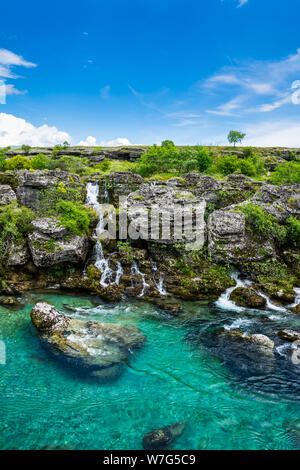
left=31, top=302, right=146, bottom=379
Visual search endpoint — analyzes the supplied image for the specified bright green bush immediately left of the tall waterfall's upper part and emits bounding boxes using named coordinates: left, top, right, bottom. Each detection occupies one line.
left=56, top=200, right=94, bottom=235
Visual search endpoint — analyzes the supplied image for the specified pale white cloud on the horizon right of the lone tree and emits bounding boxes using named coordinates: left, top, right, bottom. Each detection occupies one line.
left=244, top=121, right=300, bottom=147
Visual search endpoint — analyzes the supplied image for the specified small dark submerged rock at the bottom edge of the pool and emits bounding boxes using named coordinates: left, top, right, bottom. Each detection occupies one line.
left=143, top=421, right=185, bottom=450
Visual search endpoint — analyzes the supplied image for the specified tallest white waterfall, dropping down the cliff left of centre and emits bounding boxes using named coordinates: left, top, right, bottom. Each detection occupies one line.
left=86, top=183, right=123, bottom=287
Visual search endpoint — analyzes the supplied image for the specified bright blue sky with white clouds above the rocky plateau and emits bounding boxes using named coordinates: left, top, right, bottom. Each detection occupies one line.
left=0, top=0, right=300, bottom=146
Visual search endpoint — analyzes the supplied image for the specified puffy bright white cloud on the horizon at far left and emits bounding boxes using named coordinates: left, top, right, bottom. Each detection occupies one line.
left=0, top=113, right=71, bottom=147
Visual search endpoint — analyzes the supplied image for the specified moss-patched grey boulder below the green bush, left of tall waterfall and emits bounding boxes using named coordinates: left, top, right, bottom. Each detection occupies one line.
left=28, top=232, right=88, bottom=267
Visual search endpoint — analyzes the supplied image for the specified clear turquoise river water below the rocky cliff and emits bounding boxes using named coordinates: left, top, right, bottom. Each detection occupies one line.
left=0, top=293, right=300, bottom=450
